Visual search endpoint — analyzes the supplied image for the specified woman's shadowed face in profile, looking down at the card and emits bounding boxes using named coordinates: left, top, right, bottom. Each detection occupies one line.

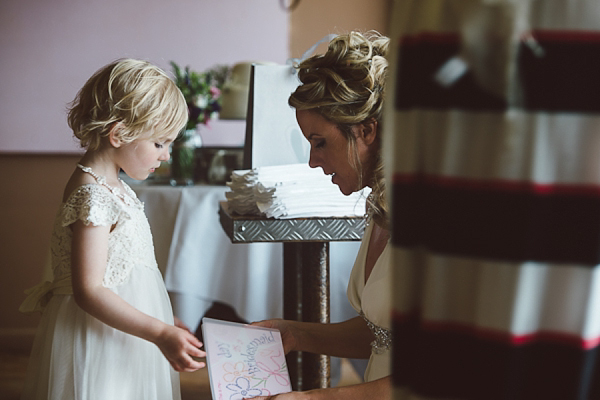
left=296, top=110, right=369, bottom=195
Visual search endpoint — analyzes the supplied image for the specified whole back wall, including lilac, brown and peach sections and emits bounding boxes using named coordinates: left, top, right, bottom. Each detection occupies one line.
left=0, top=0, right=392, bottom=348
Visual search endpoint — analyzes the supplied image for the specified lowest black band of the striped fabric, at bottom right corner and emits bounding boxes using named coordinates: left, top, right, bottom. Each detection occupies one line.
left=392, top=320, right=600, bottom=400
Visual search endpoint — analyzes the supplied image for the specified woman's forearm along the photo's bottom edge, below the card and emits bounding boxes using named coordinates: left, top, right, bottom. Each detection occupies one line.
left=247, top=376, right=392, bottom=400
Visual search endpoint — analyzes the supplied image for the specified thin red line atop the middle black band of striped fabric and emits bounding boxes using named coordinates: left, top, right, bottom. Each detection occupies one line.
left=392, top=174, right=600, bottom=197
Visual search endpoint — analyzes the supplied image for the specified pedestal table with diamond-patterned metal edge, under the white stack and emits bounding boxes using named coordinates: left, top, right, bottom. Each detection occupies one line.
left=219, top=202, right=365, bottom=391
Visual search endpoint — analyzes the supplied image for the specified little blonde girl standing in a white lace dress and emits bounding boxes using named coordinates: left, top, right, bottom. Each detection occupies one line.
left=21, top=59, right=205, bottom=400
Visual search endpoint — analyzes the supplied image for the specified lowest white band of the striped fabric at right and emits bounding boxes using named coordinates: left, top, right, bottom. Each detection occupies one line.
left=392, top=247, right=600, bottom=339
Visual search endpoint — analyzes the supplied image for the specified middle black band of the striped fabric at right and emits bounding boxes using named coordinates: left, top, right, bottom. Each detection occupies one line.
left=392, top=178, right=600, bottom=266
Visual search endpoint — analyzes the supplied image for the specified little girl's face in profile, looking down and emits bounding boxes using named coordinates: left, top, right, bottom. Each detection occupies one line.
left=118, top=132, right=177, bottom=181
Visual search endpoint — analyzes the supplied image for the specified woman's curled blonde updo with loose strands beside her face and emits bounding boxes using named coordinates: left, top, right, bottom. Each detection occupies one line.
left=289, top=31, right=389, bottom=226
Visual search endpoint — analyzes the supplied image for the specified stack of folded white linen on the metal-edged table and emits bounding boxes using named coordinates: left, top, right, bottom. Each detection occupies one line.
left=225, top=164, right=371, bottom=219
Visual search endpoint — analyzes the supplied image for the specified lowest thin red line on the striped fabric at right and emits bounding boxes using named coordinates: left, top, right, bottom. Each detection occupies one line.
left=392, top=311, right=600, bottom=350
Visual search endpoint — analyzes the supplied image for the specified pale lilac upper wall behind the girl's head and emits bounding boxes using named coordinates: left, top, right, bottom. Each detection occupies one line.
left=0, top=0, right=289, bottom=153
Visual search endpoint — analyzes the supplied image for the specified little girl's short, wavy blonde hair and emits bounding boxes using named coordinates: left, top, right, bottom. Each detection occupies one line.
left=68, top=59, right=188, bottom=150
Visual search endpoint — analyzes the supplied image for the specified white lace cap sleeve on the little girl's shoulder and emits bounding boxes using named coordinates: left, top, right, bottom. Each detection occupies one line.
left=61, top=184, right=128, bottom=226
